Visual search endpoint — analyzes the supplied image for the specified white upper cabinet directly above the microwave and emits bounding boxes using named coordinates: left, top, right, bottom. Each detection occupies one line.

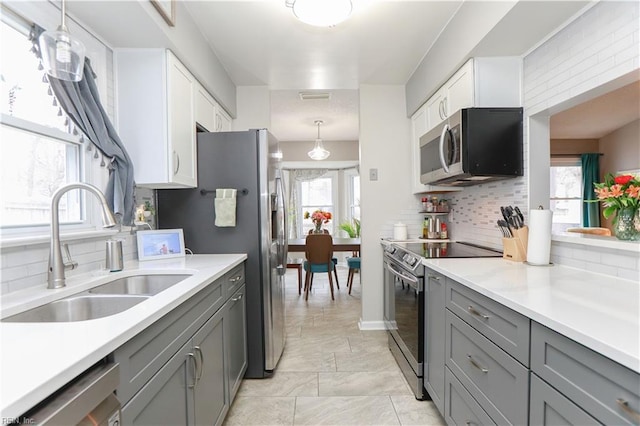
left=425, top=56, right=522, bottom=131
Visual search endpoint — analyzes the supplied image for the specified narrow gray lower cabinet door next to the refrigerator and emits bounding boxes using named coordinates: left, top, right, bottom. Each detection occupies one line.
left=225, top=286, right=247, bottom=401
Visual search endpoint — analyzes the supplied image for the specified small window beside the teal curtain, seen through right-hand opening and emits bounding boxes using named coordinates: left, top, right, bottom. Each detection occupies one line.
left=550, top=156, right=582, bottom=233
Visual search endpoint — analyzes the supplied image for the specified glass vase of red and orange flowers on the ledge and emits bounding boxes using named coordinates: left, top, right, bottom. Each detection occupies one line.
left=594, top=173, right=640, bottom=241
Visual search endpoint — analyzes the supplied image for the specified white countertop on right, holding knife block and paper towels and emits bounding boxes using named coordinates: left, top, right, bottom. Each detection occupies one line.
left=422, top=258, right=640, bottom=373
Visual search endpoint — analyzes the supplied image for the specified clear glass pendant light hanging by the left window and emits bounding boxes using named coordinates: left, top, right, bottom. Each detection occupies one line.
left=39, top=0, right=85, bottom=81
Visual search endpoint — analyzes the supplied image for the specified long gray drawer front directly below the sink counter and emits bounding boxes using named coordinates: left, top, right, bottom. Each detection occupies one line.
left=114, top=280, right=223, bottom=404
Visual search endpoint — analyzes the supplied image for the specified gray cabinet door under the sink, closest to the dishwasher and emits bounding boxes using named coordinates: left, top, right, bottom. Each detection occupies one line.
left=122, top=345, right=195, bottom=426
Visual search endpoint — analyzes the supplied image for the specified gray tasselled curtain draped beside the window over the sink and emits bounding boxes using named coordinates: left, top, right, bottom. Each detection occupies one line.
left=31, top=25, right=135, bottom=225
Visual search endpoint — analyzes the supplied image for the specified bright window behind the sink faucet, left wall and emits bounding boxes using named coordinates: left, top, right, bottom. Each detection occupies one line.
left=0, top=14, right=90, bottom=231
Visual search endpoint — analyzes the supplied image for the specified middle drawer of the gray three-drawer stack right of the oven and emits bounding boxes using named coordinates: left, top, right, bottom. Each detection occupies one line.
left=446, top=310, right=529, bottom=425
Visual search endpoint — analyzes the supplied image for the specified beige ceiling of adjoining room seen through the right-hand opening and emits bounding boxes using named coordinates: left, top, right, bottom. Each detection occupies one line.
left=550, top=81, right=640, bottom=139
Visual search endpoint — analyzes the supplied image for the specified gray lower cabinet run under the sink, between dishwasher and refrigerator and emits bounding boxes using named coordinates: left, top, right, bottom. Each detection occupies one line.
left=113, top=262, right=247, bottom=426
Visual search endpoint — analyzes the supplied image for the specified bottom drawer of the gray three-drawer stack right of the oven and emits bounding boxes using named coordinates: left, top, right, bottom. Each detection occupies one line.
left=444, top=367, right=495, bottom=426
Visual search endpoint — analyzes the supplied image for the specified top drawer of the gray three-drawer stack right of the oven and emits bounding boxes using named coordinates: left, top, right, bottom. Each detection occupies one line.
left=447, top=280, right=530, bottom=366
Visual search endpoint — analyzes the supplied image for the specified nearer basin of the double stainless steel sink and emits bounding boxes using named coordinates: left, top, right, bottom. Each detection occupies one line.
left=2, top=294, right=150, bottom=322
